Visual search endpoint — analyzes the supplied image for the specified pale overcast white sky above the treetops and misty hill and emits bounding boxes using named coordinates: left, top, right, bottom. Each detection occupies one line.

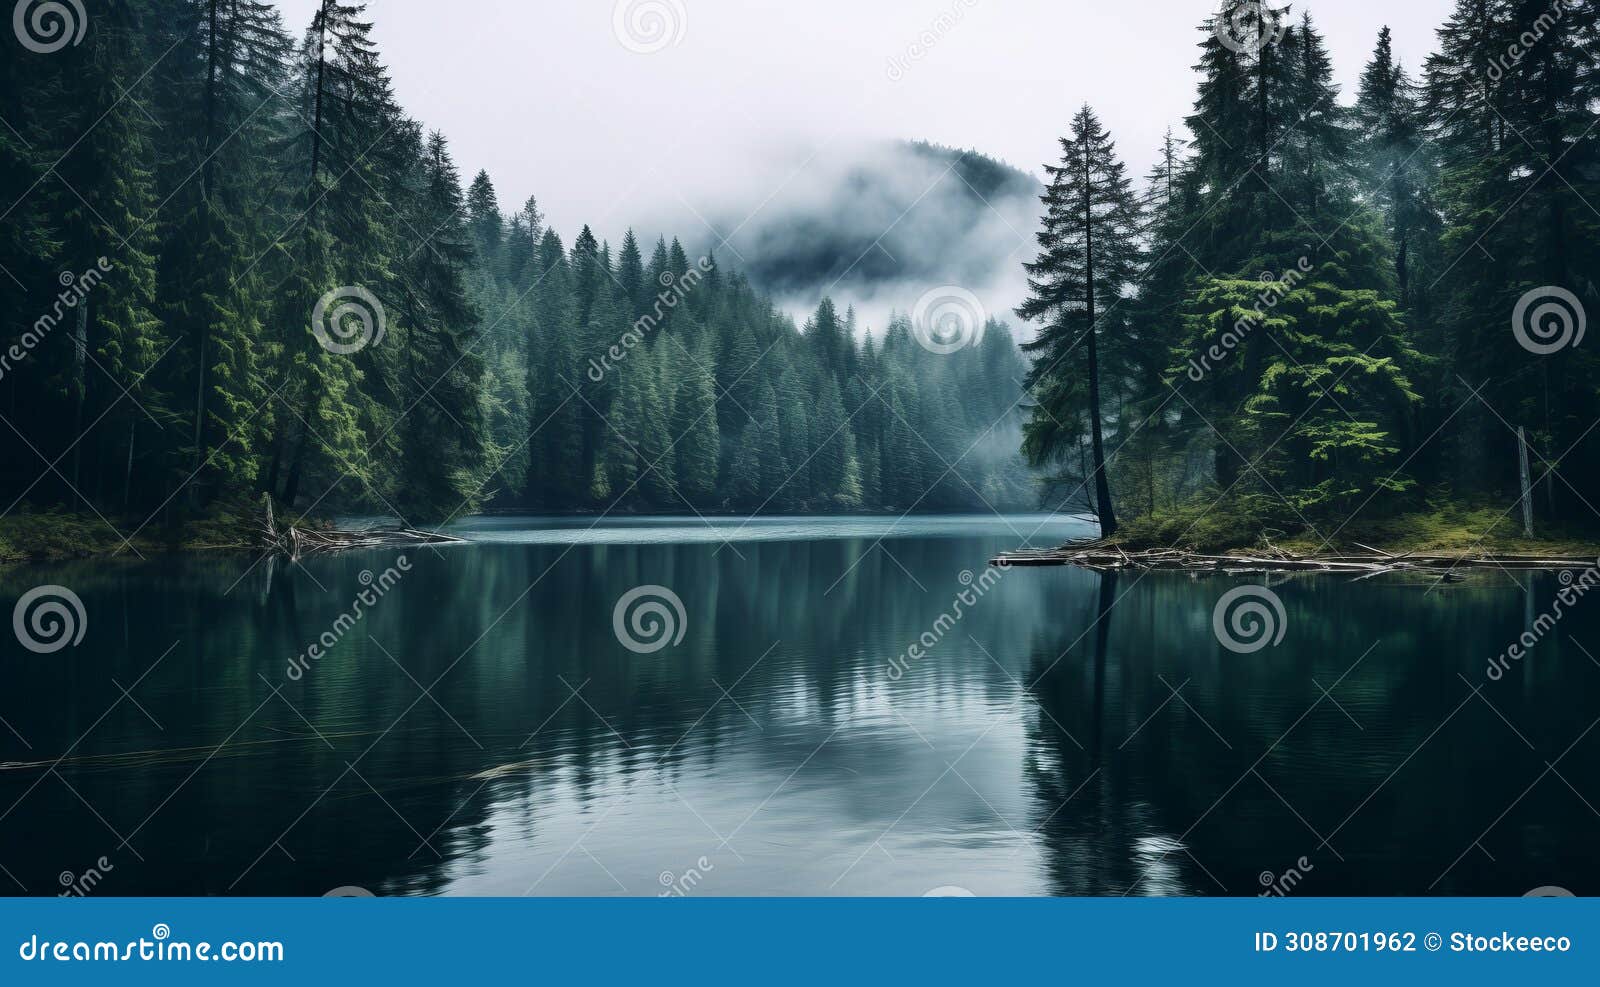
left=280, top=0, right=1453, bottom=255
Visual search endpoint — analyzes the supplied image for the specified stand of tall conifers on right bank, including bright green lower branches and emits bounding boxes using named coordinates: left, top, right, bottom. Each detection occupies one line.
left=1019, top=0, right=1600, bottom=537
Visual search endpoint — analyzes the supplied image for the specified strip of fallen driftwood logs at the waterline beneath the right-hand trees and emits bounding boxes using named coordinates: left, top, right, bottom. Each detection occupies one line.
left=989, top=542, right=1600, bottom=577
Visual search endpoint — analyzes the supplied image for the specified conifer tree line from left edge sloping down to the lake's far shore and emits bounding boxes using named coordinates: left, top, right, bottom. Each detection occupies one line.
left=0, top=0, right=1030, bottom=520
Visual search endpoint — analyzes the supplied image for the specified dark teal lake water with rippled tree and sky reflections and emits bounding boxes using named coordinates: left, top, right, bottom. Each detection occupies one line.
left=0, top=515, right=1600, bottom=896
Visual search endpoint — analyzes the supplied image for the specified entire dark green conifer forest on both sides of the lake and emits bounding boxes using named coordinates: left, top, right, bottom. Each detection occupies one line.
left=0, top=0, right=1600, bottom=541
